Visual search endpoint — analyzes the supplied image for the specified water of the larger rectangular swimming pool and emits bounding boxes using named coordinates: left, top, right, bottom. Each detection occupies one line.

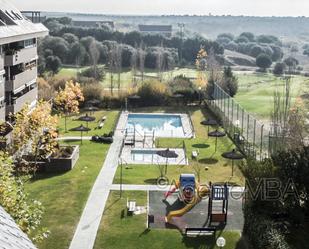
left=126, top=114, right=184, bottom=137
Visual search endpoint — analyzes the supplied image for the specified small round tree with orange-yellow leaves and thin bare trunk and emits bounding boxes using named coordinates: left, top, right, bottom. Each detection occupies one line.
left=54, top=80, right=84, bottom=132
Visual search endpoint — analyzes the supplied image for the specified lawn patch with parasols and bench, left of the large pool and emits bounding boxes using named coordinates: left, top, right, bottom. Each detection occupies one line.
left=58, top=110, right=119, bottom=136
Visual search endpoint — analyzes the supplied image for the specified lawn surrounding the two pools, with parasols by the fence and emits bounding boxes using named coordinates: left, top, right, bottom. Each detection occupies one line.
left=114, top=107, right=244, bottom=185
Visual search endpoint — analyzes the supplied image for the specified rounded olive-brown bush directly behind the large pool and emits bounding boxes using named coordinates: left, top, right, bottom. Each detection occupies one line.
left=137, top=80, right=168, bottom=106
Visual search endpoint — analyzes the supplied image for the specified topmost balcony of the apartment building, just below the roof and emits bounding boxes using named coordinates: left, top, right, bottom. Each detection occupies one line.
left=4, top=46, right=37, bottom=66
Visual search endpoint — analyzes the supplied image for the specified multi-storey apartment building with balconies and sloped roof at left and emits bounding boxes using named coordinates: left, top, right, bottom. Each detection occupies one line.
left=0, top=0, right=48, bottom=122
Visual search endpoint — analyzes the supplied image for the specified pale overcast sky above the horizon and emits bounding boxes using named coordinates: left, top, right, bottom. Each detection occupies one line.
left=9, top=0, right=309, bottom=16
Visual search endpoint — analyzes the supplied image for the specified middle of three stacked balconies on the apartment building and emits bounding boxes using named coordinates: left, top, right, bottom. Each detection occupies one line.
left=5, top=67, right=37, bottom=92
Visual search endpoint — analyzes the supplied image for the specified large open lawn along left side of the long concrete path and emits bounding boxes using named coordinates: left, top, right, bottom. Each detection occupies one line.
left=26, top=111, right=118, bottom=249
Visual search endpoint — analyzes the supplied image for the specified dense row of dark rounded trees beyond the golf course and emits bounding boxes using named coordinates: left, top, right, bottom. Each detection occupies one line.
left=39, top=18, right=224, bottom=73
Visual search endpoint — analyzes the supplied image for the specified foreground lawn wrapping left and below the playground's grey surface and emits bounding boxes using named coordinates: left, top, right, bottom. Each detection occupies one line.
left=94, top=191, right=246, bottom=249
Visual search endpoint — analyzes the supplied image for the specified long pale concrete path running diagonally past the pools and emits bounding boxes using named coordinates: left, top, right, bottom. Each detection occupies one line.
left=69, top=114, right=127, bottom=249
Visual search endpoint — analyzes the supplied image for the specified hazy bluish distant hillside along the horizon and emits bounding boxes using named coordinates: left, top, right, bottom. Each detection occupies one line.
left=43, top=12, right=309, bottom=39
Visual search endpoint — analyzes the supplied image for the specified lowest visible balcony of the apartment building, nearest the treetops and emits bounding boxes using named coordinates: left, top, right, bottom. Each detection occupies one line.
left=6, top=87, right=38, bottom=116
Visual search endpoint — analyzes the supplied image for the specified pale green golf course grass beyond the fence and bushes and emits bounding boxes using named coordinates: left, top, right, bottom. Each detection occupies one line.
left=57, top=68, right=309, bottom=119
